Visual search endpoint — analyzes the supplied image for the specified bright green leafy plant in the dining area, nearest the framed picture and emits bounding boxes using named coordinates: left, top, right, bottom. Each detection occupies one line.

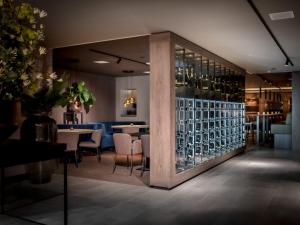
left=60, top=81, right=96, bottom=113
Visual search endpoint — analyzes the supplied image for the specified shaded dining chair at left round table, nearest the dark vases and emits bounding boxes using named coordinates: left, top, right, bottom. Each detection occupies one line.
left=57, top=132, right=79, bottom=168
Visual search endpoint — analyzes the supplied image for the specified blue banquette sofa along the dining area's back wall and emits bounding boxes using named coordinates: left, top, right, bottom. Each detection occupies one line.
left=57, top=121, right=145, bottom=149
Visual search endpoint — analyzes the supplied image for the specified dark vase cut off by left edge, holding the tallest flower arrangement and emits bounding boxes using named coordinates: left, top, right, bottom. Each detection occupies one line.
left=0, top=100, right=21, bottom=142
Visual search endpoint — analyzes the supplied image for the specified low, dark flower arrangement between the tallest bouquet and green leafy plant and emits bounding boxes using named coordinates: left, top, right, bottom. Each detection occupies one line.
left=22, top=72, right=68, bottom=114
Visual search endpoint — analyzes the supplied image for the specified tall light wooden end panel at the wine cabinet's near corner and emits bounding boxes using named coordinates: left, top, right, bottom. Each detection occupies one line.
left=150, top=32, right=175, bottom=188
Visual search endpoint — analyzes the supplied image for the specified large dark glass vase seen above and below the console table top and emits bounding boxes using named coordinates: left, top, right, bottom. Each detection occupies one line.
left=21, top=114, right=57, bottom=184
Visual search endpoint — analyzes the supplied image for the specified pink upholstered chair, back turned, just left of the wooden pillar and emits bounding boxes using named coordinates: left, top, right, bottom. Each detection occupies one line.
left=113, top=133, right=142, bottom=175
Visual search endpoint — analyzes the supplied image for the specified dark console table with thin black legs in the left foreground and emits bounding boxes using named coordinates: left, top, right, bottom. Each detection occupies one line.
left=0, top=140, right=68, bottom=225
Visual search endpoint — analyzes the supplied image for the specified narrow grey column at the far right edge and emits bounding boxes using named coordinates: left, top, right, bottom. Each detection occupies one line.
left=292, top=72, right=300, bottom=152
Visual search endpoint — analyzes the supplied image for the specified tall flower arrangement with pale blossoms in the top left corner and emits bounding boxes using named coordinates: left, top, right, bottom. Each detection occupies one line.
left=0, top=0, right=47, bottom=100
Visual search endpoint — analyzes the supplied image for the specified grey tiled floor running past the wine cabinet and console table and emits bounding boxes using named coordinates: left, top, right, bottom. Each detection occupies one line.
left=0, top=150, right=300, bottom=225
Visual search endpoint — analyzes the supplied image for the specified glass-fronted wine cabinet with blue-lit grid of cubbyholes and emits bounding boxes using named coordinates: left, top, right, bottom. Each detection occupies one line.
left=175, top=45, right=245, bottom=173
